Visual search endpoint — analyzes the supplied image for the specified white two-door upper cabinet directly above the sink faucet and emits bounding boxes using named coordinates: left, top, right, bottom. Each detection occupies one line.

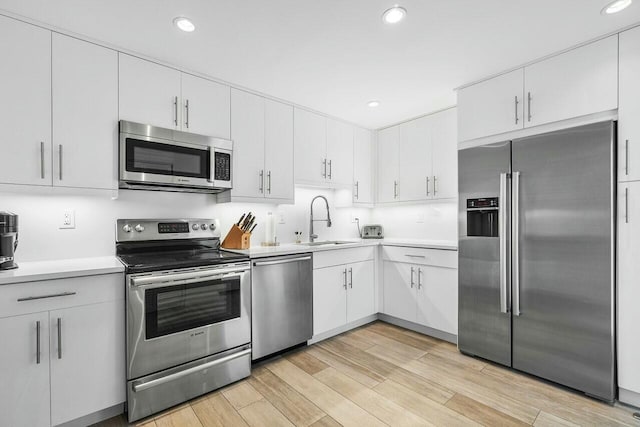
left=294, top=108, right=353, bottom=187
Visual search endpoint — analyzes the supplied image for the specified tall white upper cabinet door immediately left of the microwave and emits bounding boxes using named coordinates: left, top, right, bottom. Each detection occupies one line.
left=52, top=33, right=118, bottom=189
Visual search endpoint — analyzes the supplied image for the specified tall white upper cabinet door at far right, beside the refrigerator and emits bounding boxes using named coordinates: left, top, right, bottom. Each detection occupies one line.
left=618, top=27, right=640, bottom=181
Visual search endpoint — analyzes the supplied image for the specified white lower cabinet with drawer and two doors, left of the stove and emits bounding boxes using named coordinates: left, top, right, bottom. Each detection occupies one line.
left=0, top=274, right=126, bottom=427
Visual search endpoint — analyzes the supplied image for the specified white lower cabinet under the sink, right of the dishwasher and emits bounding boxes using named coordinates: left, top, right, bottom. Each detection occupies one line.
left=313, top=247, right=376, bottom=336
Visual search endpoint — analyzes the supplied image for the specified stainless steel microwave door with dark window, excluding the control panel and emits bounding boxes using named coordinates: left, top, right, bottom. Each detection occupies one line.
left=120, top=133, right=214, bottom=188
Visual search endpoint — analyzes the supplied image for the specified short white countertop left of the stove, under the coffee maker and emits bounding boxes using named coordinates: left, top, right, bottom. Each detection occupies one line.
left=0, top=256, right=124, bottom=285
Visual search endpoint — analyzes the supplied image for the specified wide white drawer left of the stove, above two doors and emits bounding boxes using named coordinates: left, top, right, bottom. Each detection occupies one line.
left=0, top=273, right=124, bottom=318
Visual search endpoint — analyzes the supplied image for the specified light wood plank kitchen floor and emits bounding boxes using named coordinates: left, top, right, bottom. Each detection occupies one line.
left=98, top=322, right=640, bottom=427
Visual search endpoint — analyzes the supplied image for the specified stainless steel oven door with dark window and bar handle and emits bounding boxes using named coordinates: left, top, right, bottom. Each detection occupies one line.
left=127, top=262, right=251, bottom=380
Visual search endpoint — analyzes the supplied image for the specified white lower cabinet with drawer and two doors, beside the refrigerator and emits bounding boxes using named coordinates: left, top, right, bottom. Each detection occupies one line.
left=383, top=247, right=458, bottom=335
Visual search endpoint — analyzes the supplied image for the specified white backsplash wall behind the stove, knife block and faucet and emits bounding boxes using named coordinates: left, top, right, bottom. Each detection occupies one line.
left=0, top=188, right=371, bottom=262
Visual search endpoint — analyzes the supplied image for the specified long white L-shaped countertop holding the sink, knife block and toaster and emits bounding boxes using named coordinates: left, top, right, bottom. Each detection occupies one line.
left=225, top=239, right=458, bottom=258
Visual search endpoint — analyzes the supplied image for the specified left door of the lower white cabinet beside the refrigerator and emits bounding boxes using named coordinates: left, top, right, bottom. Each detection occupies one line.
left=383, top=261, right=418, bottom=322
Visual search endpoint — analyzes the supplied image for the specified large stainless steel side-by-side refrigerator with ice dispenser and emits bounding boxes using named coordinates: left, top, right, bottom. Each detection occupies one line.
left=458, top=122, right=616, bottom=401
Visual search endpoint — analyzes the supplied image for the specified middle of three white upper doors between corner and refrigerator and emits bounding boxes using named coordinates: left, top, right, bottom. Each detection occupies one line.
left=399, top=116, right=433, bottom=201
